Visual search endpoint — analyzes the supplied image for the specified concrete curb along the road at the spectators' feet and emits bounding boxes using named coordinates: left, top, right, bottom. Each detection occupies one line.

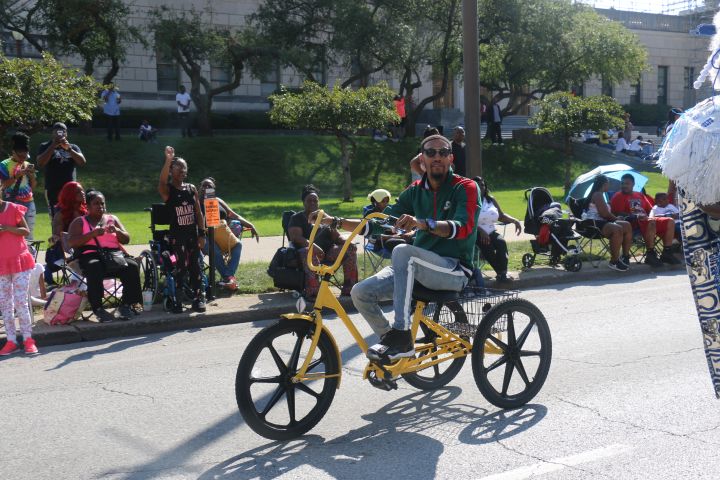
left=25, top=262, right=685, bottom=347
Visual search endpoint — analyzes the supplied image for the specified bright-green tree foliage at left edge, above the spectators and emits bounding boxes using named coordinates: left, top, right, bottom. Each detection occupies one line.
left=0, top=53, right=100, bottom=148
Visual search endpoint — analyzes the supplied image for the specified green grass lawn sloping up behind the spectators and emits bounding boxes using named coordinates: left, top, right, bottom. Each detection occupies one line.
left=31, top=131, right=667, bottom=244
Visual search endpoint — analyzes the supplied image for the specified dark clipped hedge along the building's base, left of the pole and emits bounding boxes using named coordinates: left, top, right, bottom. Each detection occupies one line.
left=92, top=108, right=282, bottom=130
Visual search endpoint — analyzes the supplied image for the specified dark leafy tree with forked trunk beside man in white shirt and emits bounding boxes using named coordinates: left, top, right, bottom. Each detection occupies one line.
left=150, top=6, right=275, bottom=135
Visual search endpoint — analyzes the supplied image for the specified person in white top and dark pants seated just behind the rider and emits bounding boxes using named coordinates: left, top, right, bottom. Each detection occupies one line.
left=473, top=177, right=522, bottom=283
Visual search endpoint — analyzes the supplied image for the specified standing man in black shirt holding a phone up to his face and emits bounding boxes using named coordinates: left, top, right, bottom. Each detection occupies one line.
left=37, top=122, right=87, bottom=222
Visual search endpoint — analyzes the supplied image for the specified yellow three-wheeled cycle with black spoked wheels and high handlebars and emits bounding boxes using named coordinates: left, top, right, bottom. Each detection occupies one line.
left=235, top=211, right=552, bottom=440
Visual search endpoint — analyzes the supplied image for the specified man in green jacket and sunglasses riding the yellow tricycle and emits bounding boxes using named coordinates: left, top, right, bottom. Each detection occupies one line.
left=309, top=135, right=479, bottom=361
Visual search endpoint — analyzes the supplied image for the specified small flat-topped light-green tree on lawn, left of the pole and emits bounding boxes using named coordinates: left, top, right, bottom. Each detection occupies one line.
left=269, top=81, right=399, bottom=202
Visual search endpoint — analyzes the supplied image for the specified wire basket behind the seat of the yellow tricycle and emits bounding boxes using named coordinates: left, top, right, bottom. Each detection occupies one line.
left=423, top=286, right=519, bottom=337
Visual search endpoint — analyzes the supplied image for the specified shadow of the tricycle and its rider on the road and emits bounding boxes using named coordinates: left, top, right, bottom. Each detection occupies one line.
left=198, top=387, right=547, bottom=480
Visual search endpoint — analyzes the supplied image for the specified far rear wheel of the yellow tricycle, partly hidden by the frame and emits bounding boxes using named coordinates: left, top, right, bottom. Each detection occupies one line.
left=402, top=302, right=467, bottom=390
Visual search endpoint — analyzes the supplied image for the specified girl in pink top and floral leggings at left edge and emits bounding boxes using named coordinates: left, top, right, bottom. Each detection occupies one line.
left=0, top=192, right=38, bottom=356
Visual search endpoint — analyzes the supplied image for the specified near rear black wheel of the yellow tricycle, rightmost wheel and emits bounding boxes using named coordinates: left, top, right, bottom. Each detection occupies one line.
left=472, top=298, right=552, bottom=408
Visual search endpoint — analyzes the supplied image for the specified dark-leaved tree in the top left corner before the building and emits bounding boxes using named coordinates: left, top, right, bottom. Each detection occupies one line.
left=0, top=0, right=146, bottom=84
